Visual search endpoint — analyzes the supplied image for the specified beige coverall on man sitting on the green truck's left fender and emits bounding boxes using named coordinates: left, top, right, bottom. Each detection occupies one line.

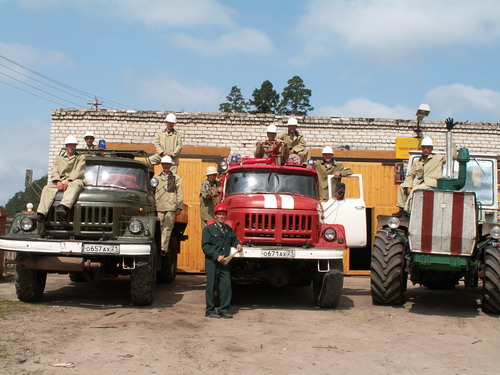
left=36, top=154, right=85, bottom=215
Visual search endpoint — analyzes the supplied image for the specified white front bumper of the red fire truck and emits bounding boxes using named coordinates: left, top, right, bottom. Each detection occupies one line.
left=235, top=246, right=344, bottom=260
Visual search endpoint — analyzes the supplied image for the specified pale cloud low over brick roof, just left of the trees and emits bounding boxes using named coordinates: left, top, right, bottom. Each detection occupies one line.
left=125, top=74, right=224, bottom=112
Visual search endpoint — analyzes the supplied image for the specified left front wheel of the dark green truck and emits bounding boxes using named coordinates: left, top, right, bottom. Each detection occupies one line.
left=16, top=255, right=47, bottom=302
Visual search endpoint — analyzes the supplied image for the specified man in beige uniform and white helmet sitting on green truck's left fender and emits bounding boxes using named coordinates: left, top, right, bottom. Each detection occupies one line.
left=35, top=135, right=85, bottom=222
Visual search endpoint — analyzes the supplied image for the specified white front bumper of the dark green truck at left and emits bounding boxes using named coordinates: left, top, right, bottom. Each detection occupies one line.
left=0, top=238, right=151, bottom=256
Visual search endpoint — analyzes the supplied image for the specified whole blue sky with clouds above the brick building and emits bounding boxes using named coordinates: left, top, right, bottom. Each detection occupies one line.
left=0, top=0, right=500, bottom=205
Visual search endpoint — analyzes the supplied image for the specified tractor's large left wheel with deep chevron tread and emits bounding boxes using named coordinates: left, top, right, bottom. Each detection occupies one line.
left=370, top=231, right=408, bottom=305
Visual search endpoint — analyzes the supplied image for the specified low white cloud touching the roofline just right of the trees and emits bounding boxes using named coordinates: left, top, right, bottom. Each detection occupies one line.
left=315, top=98, right=415, bottom=119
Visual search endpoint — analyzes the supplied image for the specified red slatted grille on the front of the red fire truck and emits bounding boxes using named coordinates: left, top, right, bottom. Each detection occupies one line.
left=245, top=213, right=314, bottom=240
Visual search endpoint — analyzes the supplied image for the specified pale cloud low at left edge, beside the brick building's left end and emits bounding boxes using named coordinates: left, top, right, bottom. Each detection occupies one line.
left=0, top=119, right=50, bottom=205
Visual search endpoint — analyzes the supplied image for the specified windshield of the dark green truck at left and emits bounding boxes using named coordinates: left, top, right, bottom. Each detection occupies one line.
left=85, top=165, right=146, bottom=191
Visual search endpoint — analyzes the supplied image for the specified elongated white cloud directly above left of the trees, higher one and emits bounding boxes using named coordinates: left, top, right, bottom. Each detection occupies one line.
left=173, top=28, right=274, bottom=57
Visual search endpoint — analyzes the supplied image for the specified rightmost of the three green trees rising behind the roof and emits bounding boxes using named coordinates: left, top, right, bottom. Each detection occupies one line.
left=279, top=76, right=314, bottom=116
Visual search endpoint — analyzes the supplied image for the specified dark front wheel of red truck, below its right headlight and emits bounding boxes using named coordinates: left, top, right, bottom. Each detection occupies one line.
left=313, top=259, right=344, bottom=308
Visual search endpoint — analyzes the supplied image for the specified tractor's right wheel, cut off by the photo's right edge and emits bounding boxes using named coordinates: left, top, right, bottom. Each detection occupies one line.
left=483, top=246, right=500, bottom=314
